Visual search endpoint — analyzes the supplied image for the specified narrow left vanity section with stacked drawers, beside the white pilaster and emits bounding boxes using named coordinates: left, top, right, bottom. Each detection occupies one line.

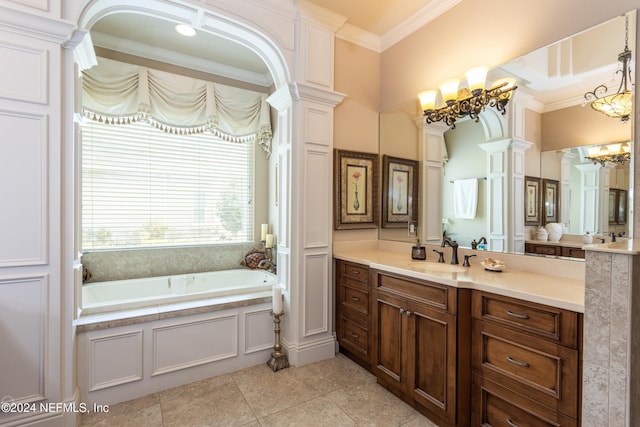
left=335, top=260, right=372, bottom=370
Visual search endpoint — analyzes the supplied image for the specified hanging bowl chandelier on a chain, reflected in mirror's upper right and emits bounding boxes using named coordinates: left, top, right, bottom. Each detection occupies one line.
left=584, top=15, right=633, bottom=123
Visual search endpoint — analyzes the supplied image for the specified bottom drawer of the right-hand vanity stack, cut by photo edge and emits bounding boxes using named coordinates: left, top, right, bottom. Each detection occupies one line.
left=471, top=375, right=578, bottom=427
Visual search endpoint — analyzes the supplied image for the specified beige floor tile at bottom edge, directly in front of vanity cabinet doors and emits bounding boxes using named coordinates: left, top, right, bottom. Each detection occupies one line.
left=327, top=382, right=421, bottom=427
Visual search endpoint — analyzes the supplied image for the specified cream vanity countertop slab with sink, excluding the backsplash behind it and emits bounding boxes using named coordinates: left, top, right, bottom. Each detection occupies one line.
left=333, top=245, right=584, bottom=313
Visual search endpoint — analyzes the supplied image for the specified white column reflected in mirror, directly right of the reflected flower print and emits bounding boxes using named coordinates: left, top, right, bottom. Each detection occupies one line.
left=415, top=116, right=449, bottom=243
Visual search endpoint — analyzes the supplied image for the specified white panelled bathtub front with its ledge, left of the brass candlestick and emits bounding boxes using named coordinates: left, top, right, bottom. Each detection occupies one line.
left=77, top=296, right=273, bottom=405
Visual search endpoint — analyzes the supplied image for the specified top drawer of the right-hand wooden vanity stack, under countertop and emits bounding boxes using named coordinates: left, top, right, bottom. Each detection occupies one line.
left=472, top=292, right=578, bottom=348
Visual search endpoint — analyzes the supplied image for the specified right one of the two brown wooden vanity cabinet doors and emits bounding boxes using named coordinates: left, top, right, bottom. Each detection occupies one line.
left=405, top=303, right=456, bottom=423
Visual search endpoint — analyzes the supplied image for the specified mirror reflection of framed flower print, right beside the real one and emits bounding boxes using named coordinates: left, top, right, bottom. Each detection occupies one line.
left=382, top=155, right=419, bottom=228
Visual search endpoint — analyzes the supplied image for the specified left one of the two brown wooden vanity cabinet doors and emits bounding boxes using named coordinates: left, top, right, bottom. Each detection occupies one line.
left=373, top=292, right=407, bottom=392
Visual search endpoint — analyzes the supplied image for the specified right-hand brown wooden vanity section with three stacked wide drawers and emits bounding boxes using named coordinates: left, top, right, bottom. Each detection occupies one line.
left=471, top=291, right=582, bottom=426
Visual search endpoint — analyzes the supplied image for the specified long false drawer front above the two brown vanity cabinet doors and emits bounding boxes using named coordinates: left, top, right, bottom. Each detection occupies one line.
left=374, top=271, right=456, bottom=312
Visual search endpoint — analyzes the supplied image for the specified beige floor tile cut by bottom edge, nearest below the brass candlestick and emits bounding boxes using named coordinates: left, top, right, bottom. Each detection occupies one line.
left=260, top=397, right=356, bottom=427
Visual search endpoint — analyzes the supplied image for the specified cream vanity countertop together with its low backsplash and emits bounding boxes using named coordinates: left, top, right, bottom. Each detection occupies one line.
left=333, top=241, right=585, bottom=313
